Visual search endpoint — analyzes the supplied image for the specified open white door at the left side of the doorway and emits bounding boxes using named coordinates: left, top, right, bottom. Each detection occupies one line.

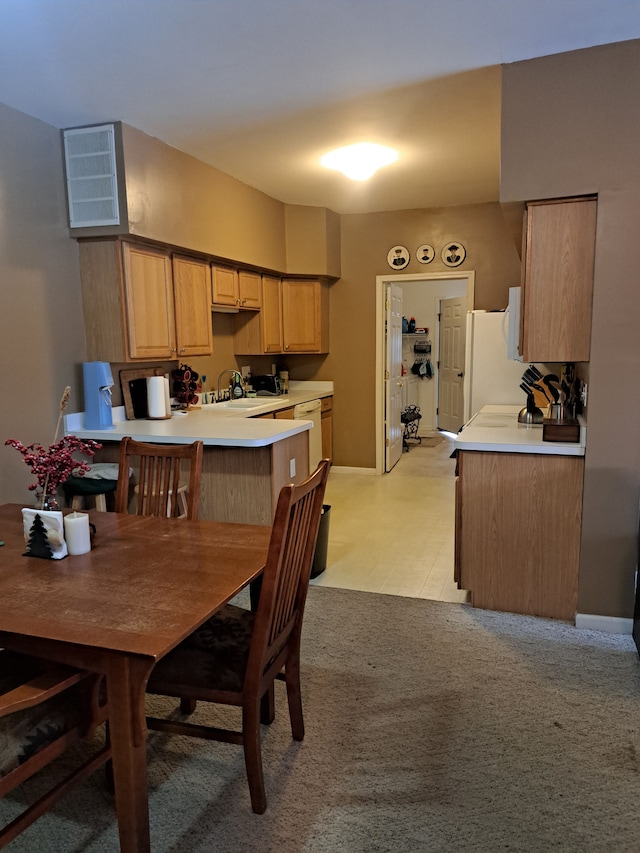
left=384, top=283, right=403, bottom=471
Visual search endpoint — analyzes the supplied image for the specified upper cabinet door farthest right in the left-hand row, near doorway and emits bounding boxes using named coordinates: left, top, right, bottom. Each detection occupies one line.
left=282, top=279, right=322, bottom=352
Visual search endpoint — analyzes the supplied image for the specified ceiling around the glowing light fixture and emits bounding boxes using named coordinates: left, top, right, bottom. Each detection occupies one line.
left=0, top=0, right=640, bottom=213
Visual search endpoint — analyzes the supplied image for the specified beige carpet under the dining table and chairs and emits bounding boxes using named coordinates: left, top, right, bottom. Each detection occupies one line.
left=0, top=587, right=640, bottom=853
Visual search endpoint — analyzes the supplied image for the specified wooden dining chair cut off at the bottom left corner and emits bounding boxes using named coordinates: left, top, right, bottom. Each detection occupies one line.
left=0, top=649, right=111, bottom=849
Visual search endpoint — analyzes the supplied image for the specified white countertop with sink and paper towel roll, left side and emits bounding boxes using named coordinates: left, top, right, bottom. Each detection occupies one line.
left=65, top=382, right=333, bottom=447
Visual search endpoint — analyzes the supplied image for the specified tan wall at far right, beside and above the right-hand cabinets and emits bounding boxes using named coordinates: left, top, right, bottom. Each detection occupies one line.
left=501, top=41, right=640, bottom=618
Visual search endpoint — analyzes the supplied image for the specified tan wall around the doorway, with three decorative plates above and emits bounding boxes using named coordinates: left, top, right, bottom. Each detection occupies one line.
left=328, top=203, right=520, bottom=468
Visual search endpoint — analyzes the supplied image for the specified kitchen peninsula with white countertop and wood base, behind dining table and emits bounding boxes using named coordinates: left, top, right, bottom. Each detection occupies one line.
left=65, top=382, right=333, bottom=524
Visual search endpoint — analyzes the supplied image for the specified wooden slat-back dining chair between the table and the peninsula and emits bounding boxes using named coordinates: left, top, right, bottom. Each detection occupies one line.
left=115, top=436, right=203, bottom=520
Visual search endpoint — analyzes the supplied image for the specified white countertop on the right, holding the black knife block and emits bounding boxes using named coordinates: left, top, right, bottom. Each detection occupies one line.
left=455, top=405, right=587, bottom=456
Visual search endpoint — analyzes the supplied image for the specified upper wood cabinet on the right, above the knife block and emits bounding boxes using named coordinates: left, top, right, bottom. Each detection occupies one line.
left=520, top=197, right=597, bottom=362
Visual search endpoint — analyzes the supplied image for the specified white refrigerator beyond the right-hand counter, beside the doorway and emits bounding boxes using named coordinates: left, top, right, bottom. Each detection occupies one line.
left=463, top=311, right=544, bottom=423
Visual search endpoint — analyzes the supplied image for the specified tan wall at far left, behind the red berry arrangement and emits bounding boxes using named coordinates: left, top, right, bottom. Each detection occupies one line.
left=0, top=104, right=86, bottom=505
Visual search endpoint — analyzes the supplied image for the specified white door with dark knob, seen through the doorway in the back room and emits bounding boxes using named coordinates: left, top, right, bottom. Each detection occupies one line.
left=438, top=296, right=467, bottom=432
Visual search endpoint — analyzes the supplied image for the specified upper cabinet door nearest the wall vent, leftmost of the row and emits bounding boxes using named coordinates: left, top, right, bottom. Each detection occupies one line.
left=123, top=243, right=176, bottom=360
